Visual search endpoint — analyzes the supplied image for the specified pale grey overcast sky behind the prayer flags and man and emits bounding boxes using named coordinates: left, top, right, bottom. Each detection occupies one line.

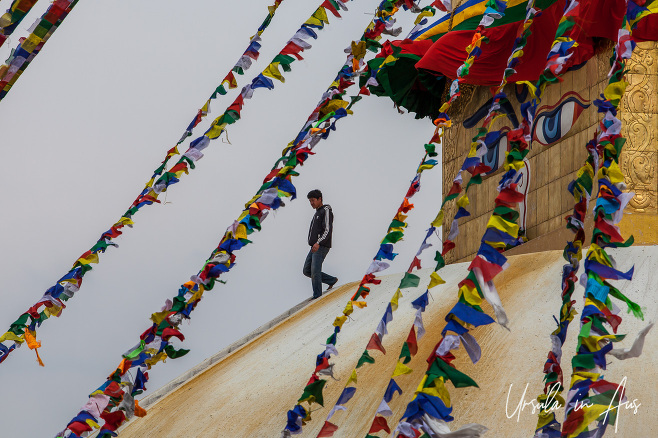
left=0, top=0, right=441, bottom=437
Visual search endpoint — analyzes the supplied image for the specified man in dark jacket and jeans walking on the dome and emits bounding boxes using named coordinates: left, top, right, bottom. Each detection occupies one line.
left=304, top=190, right=338, bottom=299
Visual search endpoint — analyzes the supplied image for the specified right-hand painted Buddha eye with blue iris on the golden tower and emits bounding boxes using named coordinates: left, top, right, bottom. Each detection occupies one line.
left=532, top=91, right=590, bottom=146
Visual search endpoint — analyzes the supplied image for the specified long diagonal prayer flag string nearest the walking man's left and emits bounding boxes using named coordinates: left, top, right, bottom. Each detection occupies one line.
left=52, top=2, right=416, bottom=438
